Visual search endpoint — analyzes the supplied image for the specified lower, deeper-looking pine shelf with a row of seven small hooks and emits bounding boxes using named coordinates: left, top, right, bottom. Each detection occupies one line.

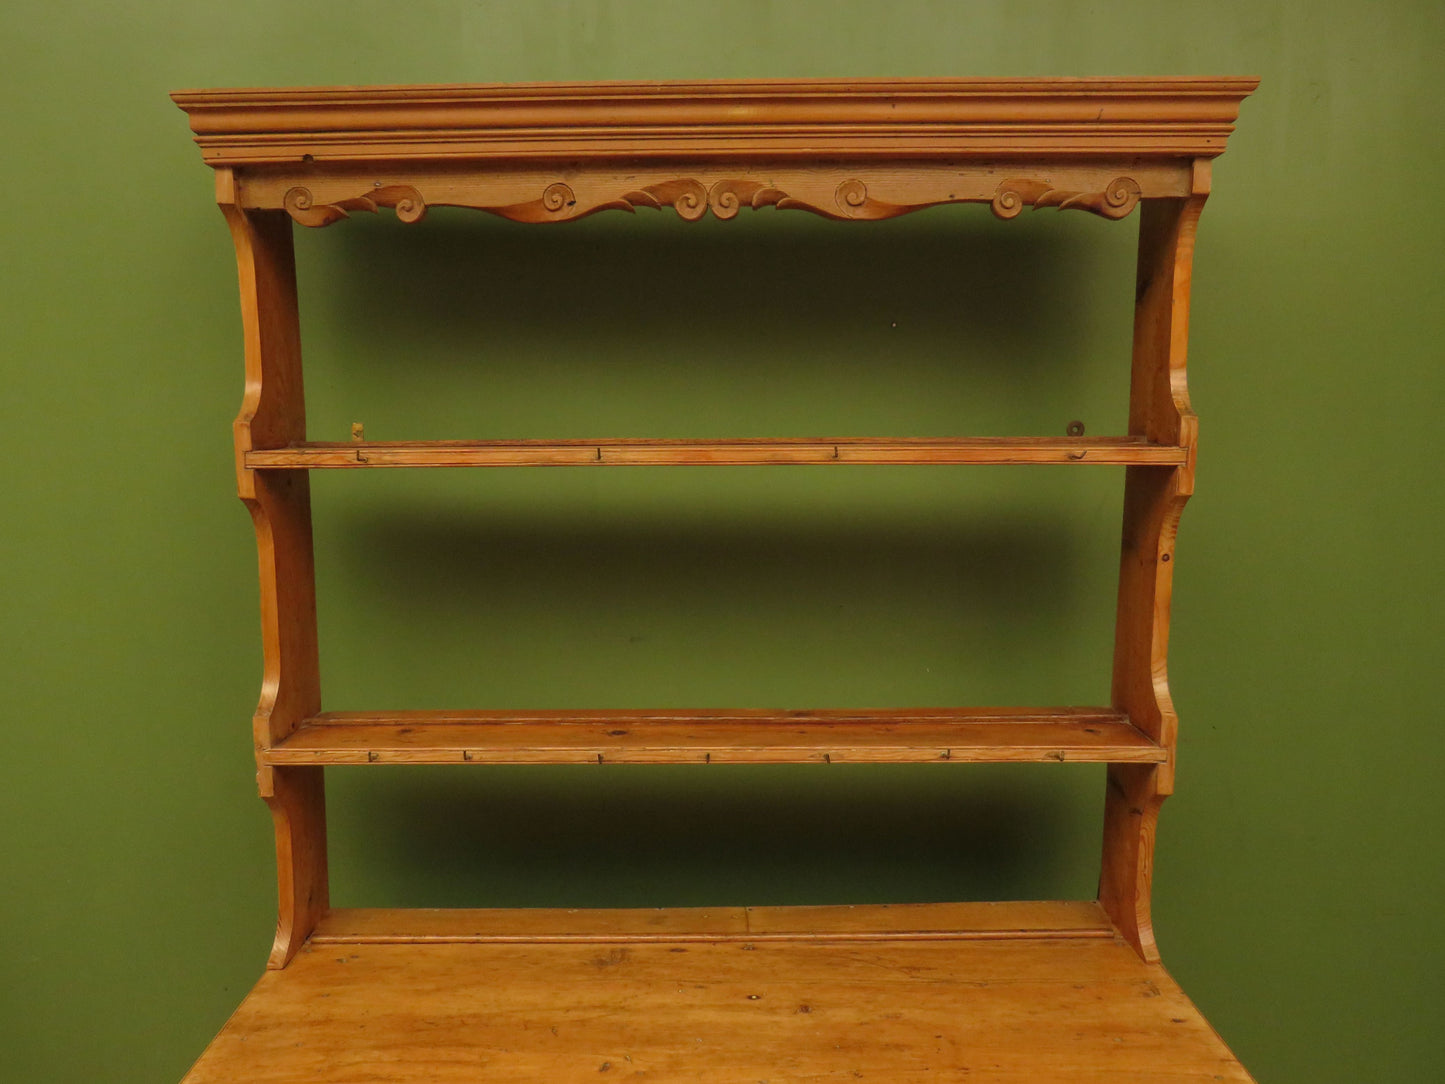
left=262, top=708, right=1169, bottom=765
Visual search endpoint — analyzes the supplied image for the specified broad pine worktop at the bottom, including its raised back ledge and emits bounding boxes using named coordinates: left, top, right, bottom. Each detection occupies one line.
left=184, top=902, right=1251, bottom=1084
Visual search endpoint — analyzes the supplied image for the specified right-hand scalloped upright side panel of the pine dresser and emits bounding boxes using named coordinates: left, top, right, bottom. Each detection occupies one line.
left=1100, top=159, right=1209, bottom=961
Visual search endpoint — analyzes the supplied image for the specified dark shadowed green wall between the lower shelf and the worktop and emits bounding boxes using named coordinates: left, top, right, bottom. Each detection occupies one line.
left=331, top=765, right=1103, bottom=906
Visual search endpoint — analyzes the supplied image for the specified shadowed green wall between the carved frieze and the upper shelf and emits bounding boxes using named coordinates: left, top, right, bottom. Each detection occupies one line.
left=299, top=207, right=1134, bottom=439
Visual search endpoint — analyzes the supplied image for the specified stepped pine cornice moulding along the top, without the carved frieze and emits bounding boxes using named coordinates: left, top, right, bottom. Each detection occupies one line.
left=172, top=77, right=1259, bottom=172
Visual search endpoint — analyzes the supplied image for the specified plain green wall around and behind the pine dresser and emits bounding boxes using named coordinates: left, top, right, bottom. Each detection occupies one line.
left=0, top=0, right=1445, bottom=1084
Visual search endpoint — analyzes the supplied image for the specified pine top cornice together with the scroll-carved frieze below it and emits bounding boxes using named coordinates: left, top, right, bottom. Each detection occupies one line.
left=172, top=78, right=1257, bottom=225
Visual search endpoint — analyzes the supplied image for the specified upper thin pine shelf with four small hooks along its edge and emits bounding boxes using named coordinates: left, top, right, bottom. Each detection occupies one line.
left=244, top=436, right=1188, bottom=470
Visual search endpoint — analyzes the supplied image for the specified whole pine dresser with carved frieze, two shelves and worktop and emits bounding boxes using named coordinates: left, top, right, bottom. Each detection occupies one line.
left=173, top=78, right=1256, bottom=1084
